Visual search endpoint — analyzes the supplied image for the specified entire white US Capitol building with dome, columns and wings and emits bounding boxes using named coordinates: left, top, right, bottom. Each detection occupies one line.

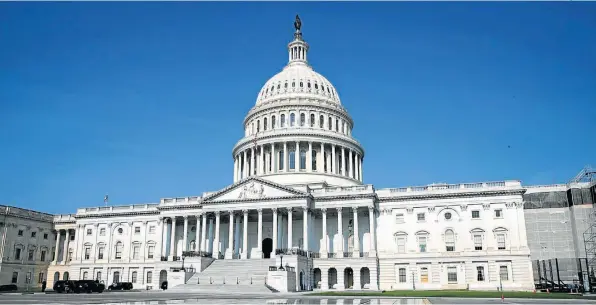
left=0, top=18, right=592, bottom=291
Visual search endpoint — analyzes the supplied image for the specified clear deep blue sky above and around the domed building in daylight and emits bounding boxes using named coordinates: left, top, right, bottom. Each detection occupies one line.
left=0, top=2, right=596, bottom=213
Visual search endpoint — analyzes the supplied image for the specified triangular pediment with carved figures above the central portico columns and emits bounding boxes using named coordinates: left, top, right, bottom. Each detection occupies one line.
left=203, top=177, right=309, bottom=202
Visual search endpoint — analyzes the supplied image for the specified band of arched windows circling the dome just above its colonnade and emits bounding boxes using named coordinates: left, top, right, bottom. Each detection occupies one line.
left=246, top=112, right=350, bottom=135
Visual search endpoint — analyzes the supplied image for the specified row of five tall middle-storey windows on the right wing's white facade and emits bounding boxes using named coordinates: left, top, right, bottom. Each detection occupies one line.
left=394, top=228, right=507, bottom=253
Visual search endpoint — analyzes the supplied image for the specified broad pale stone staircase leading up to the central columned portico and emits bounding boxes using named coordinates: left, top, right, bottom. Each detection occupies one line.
left=172, top=259, right=275, bottom=294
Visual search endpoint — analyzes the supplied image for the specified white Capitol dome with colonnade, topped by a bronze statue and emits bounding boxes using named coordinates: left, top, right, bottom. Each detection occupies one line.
left=232, top=16, right=364, bottom=186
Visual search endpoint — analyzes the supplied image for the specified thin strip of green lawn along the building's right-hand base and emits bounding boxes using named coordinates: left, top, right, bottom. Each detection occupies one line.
left=311, top=290, right=583, bottom=299
